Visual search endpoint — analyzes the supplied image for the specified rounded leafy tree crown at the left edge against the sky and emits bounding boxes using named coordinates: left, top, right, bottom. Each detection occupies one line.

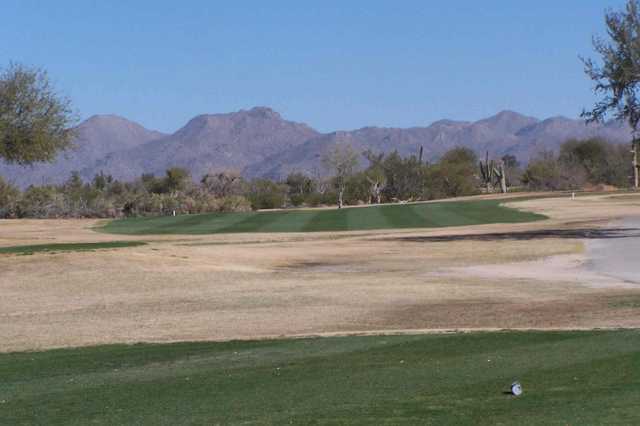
left=0, top=64, right=75, bottom=165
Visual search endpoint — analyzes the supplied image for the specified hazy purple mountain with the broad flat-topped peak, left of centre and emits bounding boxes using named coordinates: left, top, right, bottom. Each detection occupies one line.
left=82, top=107, right=318, bottom=180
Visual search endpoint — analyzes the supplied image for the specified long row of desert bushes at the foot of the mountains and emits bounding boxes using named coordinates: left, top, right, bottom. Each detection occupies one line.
left=0, top=139, right=632, bottom=218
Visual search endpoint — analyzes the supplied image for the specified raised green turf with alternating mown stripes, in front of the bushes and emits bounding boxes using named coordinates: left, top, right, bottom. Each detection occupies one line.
left=100, top=200, right=546, bottom=235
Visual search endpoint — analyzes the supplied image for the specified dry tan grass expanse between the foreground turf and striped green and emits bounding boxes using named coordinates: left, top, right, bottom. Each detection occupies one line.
left=0, top=195, right=640, bottom=351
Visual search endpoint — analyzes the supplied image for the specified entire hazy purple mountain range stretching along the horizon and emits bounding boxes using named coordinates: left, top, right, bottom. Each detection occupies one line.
left=0, top=107, right=631, bottom=188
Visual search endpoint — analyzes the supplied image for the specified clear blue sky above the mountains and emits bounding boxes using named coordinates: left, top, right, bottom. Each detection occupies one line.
left=0, top=0, right=624, bottom=131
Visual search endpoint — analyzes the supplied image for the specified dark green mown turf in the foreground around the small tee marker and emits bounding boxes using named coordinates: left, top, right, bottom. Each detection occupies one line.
left=0, top=331, right=640, bottom=425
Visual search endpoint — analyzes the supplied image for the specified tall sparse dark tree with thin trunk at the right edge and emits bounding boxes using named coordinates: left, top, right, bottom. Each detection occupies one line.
left=582, top=0, right=640, bottom=189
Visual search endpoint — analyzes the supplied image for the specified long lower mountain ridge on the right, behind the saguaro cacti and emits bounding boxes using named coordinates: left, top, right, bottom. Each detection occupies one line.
left=245, top=111, right=630, bottom=179
